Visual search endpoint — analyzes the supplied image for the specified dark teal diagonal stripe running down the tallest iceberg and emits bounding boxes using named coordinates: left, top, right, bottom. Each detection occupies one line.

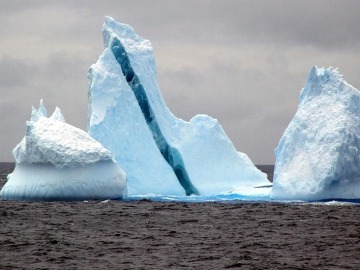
left=110, top=38, right=200, bottom=195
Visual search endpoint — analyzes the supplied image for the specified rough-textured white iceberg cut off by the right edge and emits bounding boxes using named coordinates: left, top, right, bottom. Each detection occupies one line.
left=270, top=67, right=360, bottom=200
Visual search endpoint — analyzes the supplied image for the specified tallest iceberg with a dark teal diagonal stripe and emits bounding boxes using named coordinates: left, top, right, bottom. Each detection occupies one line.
left=88, top=17, right=269, bottom=195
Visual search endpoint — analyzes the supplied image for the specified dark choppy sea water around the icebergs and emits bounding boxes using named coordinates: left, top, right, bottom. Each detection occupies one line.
left=0, top=163, right=360, bottom=269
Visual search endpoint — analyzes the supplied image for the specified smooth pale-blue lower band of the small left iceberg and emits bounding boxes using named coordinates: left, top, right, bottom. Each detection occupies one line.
left=0, top=160, right=127, bottom=201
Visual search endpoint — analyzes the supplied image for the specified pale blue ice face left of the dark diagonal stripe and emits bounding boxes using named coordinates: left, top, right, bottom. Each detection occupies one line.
left=88, top=48, right=185, bottom=196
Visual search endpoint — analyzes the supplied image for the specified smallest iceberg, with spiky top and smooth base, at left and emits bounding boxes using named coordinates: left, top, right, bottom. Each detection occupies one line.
left=0, top=100, right=127, bottom=201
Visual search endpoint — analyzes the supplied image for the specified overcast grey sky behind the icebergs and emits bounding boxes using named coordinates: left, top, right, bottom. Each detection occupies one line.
left=0, top=0, right=360, bottom=164
